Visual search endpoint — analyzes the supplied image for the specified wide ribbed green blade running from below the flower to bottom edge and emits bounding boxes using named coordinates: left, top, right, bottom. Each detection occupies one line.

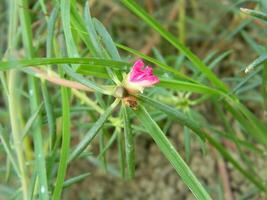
left=135, top=105, right=211, bottom=200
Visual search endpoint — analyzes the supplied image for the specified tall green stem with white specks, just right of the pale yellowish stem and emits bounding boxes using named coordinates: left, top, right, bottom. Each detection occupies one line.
left=17, top=0, right=49, bottom=200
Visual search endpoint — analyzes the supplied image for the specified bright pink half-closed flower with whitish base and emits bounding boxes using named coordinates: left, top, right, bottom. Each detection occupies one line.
left=125, top=59, right=159, bottom=93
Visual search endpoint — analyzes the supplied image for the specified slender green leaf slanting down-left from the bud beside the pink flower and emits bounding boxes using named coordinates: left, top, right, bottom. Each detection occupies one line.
left=68, top=99, right=119, bottom=162
